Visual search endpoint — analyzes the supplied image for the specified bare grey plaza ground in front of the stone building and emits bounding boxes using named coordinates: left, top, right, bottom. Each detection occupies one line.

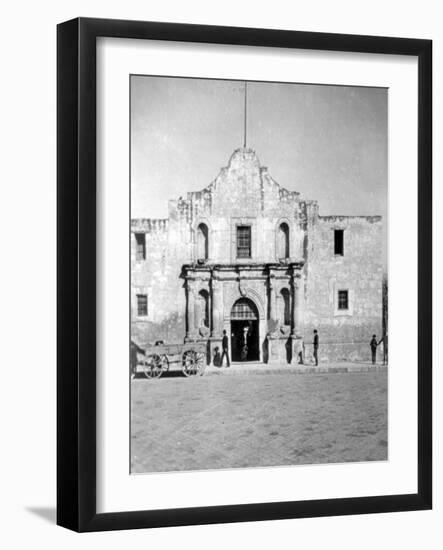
left=131, top=371, right=388, bottom=473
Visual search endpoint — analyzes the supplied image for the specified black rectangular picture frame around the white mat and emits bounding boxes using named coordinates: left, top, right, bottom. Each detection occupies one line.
left=57, top=18, right=432, bottom=531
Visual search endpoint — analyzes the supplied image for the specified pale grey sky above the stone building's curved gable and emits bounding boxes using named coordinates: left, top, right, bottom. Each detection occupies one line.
left=131, top=76, right=387, bottom=222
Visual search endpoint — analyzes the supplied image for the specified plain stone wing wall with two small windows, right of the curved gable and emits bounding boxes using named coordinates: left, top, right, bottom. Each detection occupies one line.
left=304, top=216, right=383, bottom=361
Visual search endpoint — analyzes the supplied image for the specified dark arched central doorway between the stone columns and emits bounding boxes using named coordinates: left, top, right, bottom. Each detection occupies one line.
left=231, top=298, right=260, bottom=361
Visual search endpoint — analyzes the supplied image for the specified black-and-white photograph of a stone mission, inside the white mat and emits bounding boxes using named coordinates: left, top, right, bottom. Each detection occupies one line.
left=128, top=74, right=389, bottom=474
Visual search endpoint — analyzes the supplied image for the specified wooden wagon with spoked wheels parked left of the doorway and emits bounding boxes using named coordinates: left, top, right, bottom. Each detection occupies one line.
left=137, top=342, right=206, bottom=378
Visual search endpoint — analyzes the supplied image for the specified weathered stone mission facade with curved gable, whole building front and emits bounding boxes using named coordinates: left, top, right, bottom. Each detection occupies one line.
left=131, top=148, right=383, bottom=363
